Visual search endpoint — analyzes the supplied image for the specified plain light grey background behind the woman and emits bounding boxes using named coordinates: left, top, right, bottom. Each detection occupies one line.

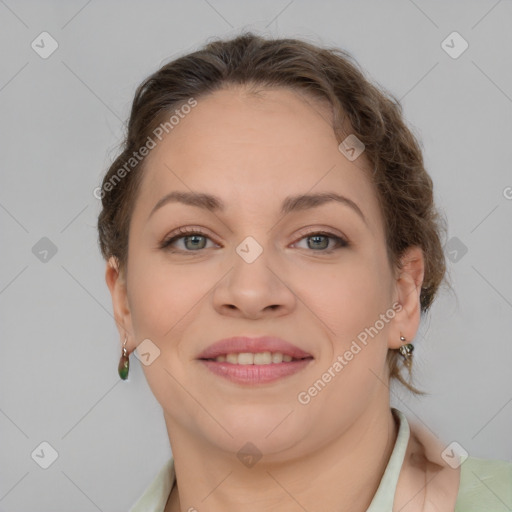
left=0, top=0, right=512, bottom=512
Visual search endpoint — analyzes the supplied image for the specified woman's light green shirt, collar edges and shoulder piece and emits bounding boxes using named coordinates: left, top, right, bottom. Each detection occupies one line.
left=129, top=409, right=512, bottom=512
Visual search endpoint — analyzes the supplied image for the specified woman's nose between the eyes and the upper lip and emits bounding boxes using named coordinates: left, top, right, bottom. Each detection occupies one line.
left=213, top=243, right=297, bottom=320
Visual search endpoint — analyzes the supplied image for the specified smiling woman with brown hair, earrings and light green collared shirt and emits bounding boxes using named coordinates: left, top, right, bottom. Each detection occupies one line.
left=98, top=33, right=512, bottom=512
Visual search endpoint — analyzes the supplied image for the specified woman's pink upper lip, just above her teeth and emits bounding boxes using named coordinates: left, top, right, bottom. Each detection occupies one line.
left=197, top=336, right=313, bottom=360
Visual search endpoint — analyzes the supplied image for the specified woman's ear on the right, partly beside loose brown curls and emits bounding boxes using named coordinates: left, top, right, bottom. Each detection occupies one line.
left=388, top=246, right=425, bottom=349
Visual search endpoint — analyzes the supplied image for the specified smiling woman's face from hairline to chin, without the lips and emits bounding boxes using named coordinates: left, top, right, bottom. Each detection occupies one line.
left=107, top=87, right=419, bottom=460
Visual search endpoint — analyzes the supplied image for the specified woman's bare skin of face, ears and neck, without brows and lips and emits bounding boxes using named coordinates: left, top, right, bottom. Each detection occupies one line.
left=106, top=86, right=424, bottom=512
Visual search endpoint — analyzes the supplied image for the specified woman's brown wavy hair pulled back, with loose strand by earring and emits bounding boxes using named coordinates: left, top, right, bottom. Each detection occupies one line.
left=98, top=32, right=446, bottom=394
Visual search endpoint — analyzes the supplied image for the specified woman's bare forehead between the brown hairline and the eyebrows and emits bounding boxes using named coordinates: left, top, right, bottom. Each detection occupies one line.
left=136, top=86, right=378, bottom=232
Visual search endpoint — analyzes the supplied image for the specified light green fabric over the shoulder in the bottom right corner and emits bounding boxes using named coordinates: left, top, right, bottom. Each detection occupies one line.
left=455, top=457, right=512, bottom=512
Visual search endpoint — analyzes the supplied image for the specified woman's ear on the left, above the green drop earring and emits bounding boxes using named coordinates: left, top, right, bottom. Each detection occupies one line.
left=105, top=256, right=135, bottom=353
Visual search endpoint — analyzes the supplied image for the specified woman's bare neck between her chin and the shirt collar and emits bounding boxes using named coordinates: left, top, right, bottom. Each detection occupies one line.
left=165, top=402, right=398, bottom=512
